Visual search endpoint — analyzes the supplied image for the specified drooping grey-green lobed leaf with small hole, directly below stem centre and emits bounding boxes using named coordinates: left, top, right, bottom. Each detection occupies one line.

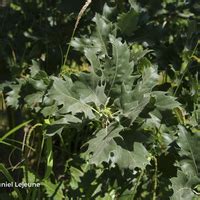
left=87, top=126, right=149, bottom=169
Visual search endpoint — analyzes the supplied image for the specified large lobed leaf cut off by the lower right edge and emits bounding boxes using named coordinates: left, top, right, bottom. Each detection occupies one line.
left=171, top=125, right=200, bottom=200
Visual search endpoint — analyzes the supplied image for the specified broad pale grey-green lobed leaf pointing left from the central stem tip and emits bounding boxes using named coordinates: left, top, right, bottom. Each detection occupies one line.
left=45, top=74, right=107, bottom=119
